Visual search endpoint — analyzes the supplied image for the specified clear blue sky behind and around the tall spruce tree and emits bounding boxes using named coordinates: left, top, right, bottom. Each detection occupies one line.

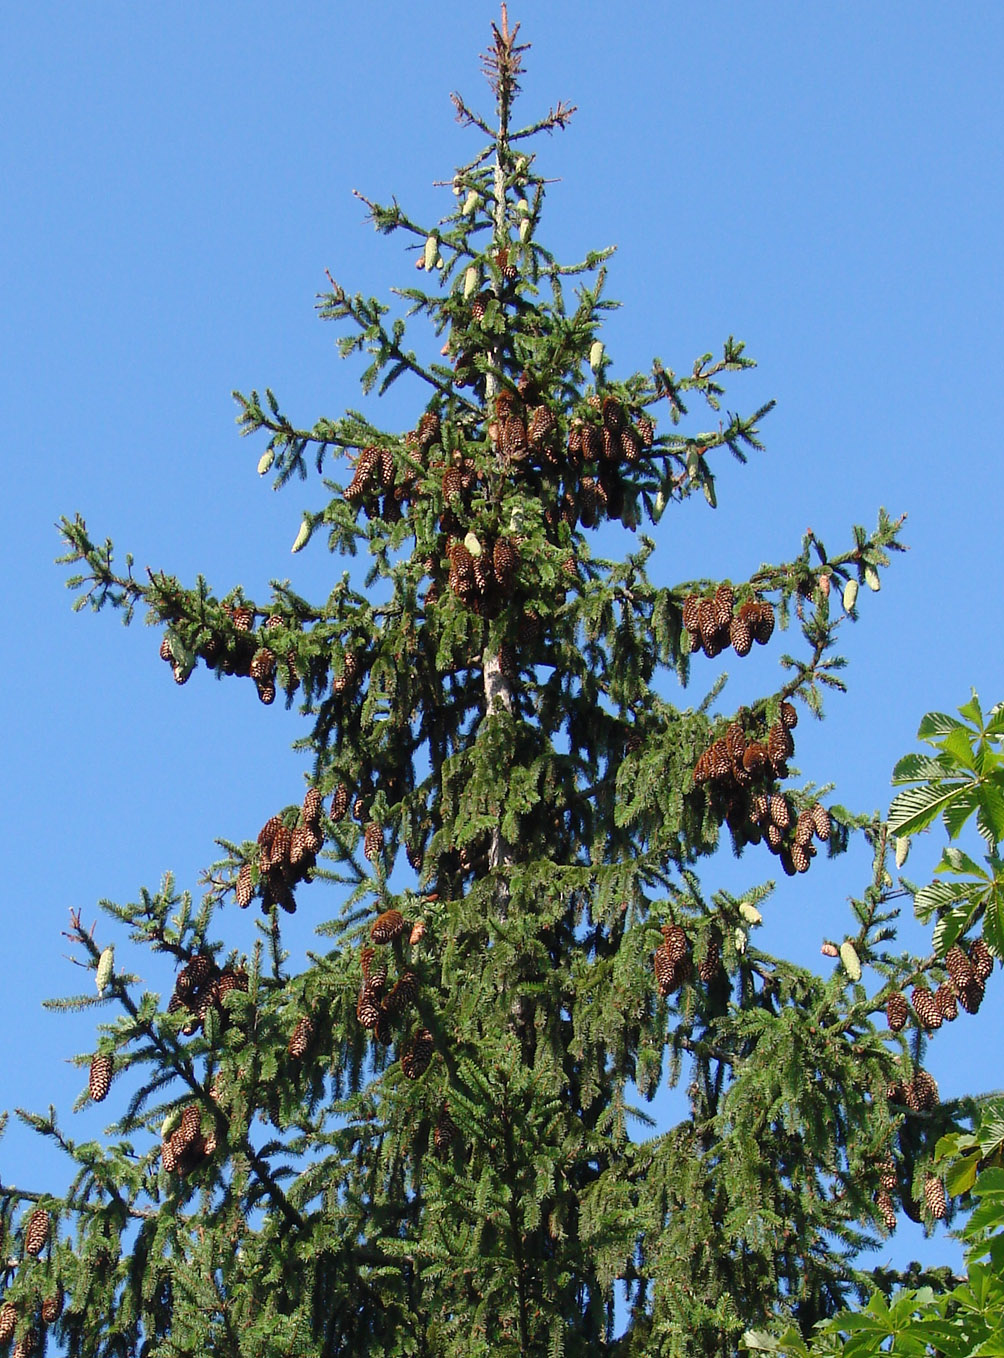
left=0, top=0, right=1004, bottom=1287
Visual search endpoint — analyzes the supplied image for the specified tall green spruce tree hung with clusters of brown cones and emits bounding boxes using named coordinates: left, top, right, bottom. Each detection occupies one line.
left=0, top=7, right=989, bottom=1358
